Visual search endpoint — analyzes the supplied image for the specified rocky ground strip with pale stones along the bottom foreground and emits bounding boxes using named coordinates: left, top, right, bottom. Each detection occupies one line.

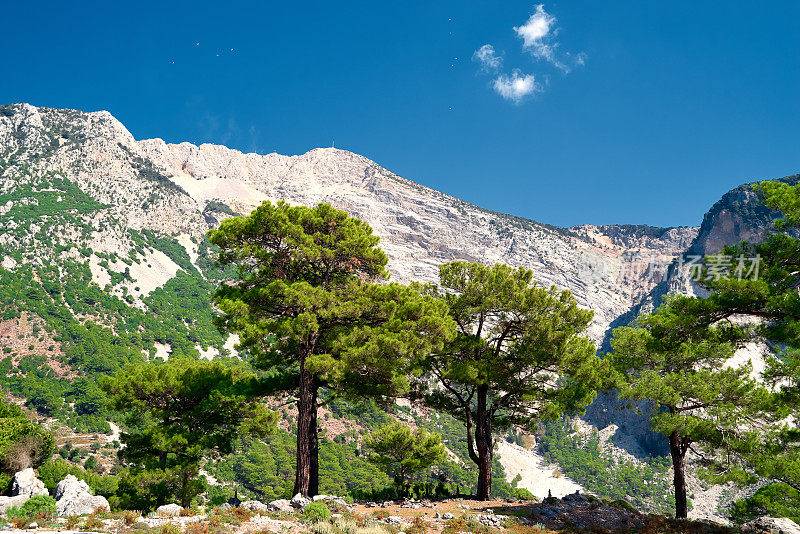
left=0, top=486, right=800, bottom=534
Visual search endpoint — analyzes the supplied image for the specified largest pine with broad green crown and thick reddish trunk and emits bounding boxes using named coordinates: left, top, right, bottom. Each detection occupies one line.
left=209, top=202, right=453, bottom=495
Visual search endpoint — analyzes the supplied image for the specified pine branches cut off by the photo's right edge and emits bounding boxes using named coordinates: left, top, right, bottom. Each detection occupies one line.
left=680, top=181, right=800, bottom=498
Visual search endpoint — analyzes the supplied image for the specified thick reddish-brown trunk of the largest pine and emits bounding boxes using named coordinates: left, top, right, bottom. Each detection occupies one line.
left=294, top=358, right=319, bottom=497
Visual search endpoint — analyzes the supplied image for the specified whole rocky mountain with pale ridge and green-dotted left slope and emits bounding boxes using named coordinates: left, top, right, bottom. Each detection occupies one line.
left=0, top=104, right=800, bottom=520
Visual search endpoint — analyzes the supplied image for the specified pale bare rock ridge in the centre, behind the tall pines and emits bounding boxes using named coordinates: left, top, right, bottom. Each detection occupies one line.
left=138, top=139, right=696, bottom=339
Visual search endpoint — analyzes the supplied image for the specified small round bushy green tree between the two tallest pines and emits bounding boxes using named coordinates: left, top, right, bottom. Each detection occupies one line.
left=364, top=422, right=445, bottom=495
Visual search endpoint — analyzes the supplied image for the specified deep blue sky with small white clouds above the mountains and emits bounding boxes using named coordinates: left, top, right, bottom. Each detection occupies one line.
left=0, top=0, right=800, bottom=226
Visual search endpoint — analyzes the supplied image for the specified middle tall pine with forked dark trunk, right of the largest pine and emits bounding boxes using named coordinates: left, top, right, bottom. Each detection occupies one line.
left=419, top=262, right=603, bottom=500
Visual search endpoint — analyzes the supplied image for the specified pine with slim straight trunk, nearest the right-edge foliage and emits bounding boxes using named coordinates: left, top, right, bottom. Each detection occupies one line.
left=608, top=296, right=769, bottom=518
